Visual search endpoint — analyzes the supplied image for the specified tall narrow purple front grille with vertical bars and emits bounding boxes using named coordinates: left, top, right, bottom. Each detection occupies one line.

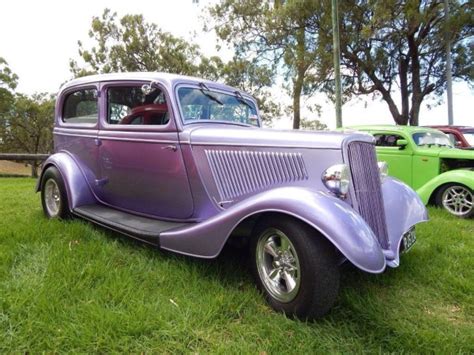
left=348, top=142, right=389, bottom=249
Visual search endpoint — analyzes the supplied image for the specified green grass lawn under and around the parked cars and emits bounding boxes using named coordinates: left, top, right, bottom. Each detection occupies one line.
left=0, top=178, right=474, bottom=354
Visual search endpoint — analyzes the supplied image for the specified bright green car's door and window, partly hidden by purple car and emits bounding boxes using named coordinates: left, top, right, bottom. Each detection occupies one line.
left=371, top=132, right=413, bottom=185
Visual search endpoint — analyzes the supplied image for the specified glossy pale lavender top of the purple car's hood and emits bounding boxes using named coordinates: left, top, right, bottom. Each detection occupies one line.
left=183, top=123, right=373, bottom=149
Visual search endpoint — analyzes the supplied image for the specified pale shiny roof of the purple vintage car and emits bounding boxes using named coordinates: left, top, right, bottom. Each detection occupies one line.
left=60, top=72, right=243, bottom=96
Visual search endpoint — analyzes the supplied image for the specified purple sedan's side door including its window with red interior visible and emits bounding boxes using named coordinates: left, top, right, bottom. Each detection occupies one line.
left=98, top=82, right=193, bottom=219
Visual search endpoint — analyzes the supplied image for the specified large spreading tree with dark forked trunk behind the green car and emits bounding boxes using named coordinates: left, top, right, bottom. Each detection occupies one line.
left=313, top=0, right=474, bottom=125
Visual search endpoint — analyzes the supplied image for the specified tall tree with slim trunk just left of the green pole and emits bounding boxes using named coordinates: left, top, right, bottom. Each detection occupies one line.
left=209, top=0, right=321, bottom=129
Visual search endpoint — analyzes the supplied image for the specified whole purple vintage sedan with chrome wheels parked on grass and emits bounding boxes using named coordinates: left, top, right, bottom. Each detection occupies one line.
left=37, top=73, right=427, bottom=319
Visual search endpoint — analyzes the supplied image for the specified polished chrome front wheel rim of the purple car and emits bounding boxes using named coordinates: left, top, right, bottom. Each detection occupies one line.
left=256, top=228, right=301, bottom=303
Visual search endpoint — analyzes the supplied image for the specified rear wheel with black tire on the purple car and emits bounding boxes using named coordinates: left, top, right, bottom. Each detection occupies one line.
left=41, top=166, right=71, bottom=219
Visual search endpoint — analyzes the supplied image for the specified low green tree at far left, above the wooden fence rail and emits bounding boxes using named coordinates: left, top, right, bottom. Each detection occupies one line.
left=0, top=94, right=55, bottom=177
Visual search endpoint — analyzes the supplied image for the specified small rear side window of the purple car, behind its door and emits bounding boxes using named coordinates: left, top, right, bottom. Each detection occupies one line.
left=62, top=89, right=99, bottom=124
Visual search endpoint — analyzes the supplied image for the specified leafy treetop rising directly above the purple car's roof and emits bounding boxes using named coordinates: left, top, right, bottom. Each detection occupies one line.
left=70, top=9, right=220, bottom=76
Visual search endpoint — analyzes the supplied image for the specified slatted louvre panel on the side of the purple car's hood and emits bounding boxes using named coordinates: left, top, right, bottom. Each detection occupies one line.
left=205, top=150, right=308, bottom=200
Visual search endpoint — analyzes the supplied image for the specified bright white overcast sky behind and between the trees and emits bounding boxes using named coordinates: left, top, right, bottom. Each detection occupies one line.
left=0, top=0, right=474, bottom=128
